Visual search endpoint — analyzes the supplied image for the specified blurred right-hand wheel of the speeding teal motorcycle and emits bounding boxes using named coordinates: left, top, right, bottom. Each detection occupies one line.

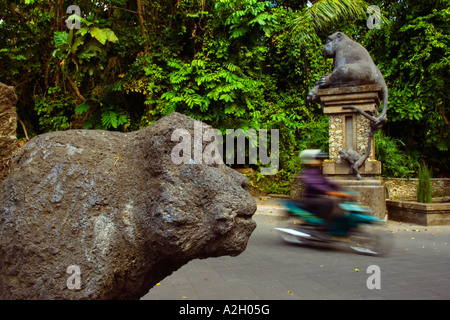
left=350, top=225, right=392, bottom=256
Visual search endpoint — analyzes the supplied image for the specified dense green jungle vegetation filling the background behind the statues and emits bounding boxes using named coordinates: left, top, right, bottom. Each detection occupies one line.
left=0, top=0, right=450, bottom=192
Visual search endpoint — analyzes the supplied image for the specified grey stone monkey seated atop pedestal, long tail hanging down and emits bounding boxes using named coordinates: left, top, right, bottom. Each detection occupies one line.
left=308, top=31, right=388, bottom=130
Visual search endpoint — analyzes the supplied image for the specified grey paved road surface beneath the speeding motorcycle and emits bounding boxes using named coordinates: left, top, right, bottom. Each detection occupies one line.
left=143, top=198, right=450, bottom=300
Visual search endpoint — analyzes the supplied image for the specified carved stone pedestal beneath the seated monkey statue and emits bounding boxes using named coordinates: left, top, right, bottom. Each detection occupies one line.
left=318, top=85, right=386, bottom=218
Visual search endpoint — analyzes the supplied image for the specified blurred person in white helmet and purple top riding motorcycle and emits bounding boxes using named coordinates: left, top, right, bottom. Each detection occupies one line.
left=298, top=149, right=343, bottom=226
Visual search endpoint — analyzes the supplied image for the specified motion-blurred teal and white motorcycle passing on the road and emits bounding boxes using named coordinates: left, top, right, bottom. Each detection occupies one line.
left=275, top=192, right=392, bottom=256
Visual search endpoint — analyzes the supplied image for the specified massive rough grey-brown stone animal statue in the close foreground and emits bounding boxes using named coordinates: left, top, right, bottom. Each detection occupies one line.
left=0, top=113, right=256, bottom=299
